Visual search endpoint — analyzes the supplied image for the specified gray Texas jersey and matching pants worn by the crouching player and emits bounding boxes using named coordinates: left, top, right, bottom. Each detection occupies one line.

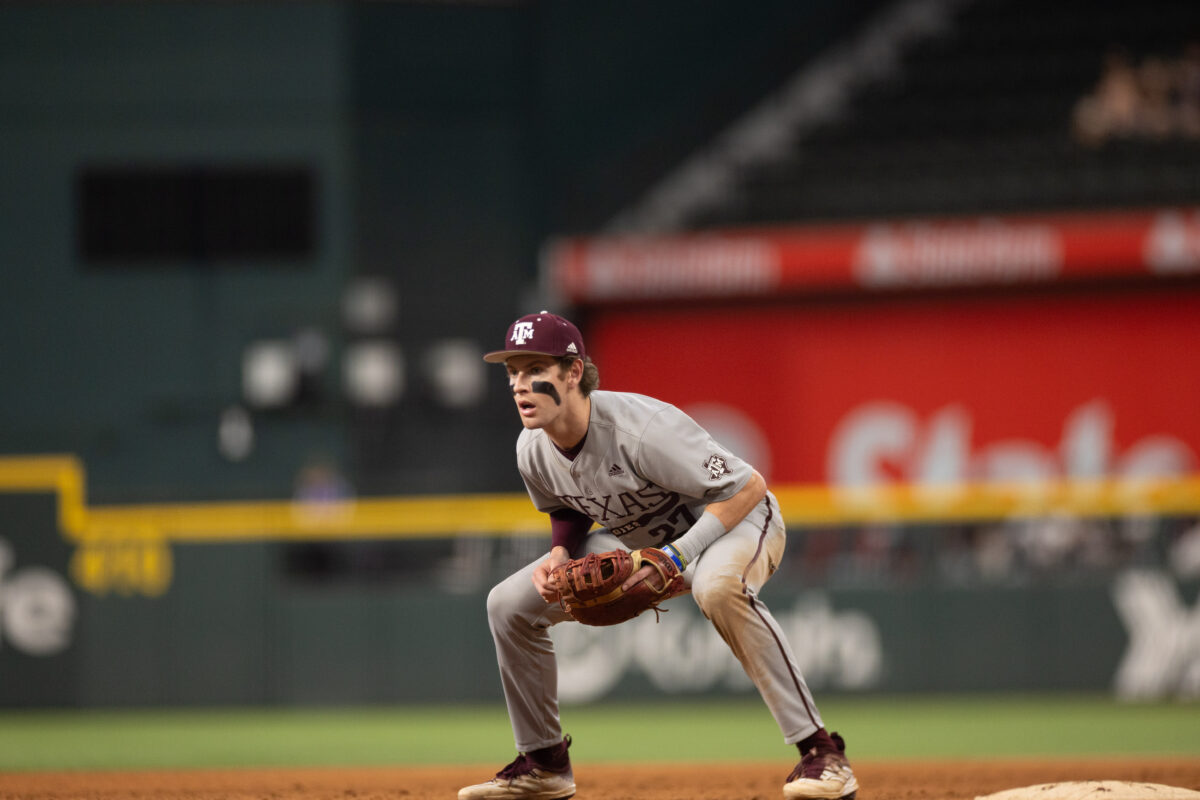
left=487, top=391, right=823, bottom=752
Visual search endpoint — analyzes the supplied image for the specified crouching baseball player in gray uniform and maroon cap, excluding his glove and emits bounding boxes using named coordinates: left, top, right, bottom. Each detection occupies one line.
left=458, top=312, right=858, bottom=800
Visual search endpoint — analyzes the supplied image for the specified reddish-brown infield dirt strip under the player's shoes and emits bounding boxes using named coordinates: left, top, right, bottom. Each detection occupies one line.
left=0, top=758, right=1200, bottom=800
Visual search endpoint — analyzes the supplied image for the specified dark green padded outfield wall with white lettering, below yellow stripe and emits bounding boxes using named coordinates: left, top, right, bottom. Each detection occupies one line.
left=0, top=474, right=1200, bottom=708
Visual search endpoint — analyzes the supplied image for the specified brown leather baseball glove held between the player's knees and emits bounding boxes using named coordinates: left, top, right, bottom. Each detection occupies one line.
left=550, top=547, right=685, bottom=625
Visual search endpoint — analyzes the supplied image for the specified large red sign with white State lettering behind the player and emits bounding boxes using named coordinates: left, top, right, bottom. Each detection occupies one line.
left=586, top=287, right=1200, bottom=486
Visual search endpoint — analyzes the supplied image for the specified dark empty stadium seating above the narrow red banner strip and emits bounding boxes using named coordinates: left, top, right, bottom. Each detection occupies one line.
left=685, top=0, right=1200, bottom=229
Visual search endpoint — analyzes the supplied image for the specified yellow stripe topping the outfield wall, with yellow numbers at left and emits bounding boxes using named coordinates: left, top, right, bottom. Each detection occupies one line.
left=0, top=455, right=1200, bottom=595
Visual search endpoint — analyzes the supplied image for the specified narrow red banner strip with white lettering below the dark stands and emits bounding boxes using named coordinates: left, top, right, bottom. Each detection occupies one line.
left=542, top=207, right=1200, bottom=306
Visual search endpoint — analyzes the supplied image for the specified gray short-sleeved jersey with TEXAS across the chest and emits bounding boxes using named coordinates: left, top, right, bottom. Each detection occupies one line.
left=517, top=391, right=752, bottom=549
